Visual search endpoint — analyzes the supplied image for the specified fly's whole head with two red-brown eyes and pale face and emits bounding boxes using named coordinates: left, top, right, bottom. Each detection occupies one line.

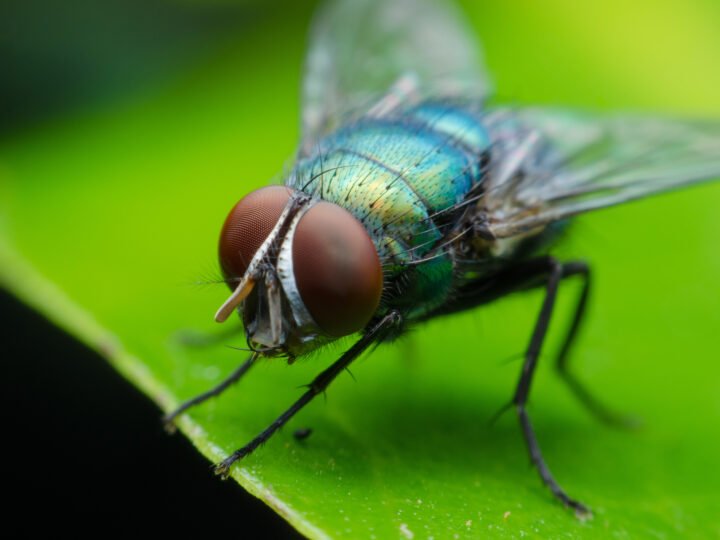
left=215, top=186, right=383, bottom=357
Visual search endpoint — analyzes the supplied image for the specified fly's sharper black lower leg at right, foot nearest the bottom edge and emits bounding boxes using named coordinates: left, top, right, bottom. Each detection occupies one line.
left=512, top=257, right=590, bottom=515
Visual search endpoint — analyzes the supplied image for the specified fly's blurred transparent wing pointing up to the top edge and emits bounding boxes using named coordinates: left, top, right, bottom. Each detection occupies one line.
left=302, top=0, right=489, bottom=154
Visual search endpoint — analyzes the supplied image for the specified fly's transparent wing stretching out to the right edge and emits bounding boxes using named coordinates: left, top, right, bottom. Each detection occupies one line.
left=483, top=108, right=720, bottom=238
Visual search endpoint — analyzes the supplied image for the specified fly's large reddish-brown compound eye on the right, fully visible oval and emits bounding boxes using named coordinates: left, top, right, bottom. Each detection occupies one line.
left=292, top=202, right=383, bottom=337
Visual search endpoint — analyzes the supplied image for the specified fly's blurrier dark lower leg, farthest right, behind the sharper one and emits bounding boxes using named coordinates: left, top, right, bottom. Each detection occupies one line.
left=555, top=261, right=637, bottom=428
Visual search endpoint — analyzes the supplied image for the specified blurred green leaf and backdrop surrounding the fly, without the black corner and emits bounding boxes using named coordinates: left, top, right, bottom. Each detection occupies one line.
left=0, top=0, right=720, bottom=538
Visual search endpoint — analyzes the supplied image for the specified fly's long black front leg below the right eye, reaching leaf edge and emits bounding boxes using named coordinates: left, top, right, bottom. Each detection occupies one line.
left=215, top=311, right=402, bottom=478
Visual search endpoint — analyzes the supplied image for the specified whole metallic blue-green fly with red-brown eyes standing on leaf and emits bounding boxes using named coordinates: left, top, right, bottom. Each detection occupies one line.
left=165, top=0, right=720, bottom=515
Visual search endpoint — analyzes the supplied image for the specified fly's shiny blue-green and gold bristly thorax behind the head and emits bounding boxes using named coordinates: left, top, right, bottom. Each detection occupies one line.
left=287, top=102, right=490, bottom=318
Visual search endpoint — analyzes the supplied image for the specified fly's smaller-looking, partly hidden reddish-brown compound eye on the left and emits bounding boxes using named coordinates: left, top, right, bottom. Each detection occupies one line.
left=219, top=186, right=292, bottom=289
